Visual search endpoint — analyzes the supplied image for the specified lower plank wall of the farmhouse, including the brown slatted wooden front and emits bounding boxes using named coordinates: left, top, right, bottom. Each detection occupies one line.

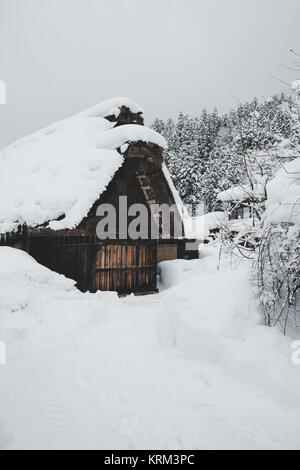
left=29, top=236, right=157, bottom=293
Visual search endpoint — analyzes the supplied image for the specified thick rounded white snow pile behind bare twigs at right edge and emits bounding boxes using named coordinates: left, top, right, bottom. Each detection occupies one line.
left=266, top=158, right=300, bottom=226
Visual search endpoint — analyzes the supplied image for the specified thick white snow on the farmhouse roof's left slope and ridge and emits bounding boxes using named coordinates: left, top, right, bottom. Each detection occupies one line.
left=0, top=98, right=167, bottom=233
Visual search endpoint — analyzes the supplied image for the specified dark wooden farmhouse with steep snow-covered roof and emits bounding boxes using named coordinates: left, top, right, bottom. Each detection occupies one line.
left=0, top=98, right=198, bottom=294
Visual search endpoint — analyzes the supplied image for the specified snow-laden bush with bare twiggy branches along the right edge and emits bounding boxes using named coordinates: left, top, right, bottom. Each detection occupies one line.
left=256, top=81, right=300, bottom=333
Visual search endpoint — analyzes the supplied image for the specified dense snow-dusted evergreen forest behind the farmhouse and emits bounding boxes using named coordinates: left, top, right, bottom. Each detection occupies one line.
left=153, top=91, right=299, bottom=211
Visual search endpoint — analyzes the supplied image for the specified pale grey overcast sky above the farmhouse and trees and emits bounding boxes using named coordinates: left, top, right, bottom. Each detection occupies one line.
left=0, top=0, right=300, bottom=148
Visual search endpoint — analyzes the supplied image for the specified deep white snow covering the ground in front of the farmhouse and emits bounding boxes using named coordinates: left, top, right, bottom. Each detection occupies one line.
left=0, top=248, right=300, bottom=450
